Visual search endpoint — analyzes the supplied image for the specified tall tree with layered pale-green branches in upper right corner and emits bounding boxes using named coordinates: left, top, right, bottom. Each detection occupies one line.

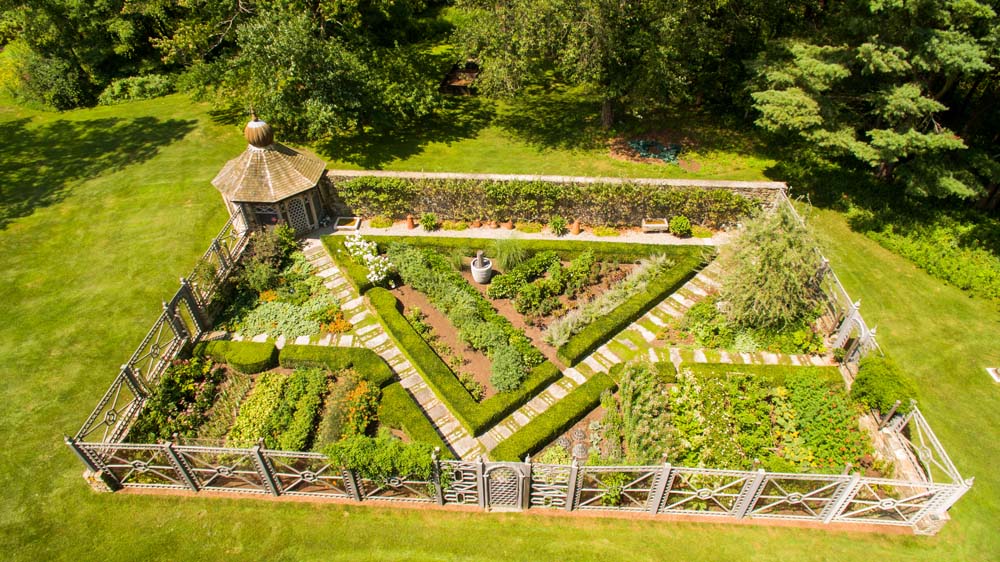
left=751, top=0, right=1000, bottom=197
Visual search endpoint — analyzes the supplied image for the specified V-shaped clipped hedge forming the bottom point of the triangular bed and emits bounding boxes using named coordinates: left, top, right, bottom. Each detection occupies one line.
left=368, top=288, right=562, bottom=436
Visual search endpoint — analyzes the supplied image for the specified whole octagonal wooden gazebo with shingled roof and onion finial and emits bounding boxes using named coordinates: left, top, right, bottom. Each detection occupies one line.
left=212, top=115, right=326, bottom=235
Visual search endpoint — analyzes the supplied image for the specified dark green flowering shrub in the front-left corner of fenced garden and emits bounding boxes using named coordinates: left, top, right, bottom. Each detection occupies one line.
left=129, top=357, right=224, bottom=443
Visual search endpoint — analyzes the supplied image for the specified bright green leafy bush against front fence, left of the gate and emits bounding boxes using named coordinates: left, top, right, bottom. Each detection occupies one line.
left=323, top=433, right=434, bottom=482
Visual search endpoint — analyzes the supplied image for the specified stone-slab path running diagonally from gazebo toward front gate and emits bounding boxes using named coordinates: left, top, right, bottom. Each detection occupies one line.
left=303, top=234, right=484, bottom=458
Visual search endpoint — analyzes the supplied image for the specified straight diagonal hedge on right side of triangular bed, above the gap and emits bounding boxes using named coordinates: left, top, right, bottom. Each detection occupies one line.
left=558, top=252, right=705, bottom=367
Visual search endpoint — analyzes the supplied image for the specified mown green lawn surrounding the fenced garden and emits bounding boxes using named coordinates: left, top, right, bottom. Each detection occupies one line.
left=0, top=96, right=1000, bottom=561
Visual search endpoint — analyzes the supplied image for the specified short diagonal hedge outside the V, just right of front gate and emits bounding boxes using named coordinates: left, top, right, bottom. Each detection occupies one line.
left=490, top=373, right=615, bottom=461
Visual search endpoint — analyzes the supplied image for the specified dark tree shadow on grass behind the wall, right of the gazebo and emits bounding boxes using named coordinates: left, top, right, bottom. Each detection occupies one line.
left=316, top=96, right=496, bottom=170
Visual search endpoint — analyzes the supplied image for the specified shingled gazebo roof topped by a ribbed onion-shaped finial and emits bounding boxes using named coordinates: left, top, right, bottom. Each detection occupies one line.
left=212, top=115, right=326, bottom=203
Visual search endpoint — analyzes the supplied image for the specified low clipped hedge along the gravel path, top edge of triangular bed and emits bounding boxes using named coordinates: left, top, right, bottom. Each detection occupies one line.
left=368, top=236, right=704, bottom=264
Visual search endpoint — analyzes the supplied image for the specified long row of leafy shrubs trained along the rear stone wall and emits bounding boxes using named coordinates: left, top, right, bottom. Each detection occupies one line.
left=333, top=176, right=761, bottom=227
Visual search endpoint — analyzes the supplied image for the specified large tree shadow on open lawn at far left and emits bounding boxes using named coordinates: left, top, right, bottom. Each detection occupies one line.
left=0, top=117, right=197, bottom=230
